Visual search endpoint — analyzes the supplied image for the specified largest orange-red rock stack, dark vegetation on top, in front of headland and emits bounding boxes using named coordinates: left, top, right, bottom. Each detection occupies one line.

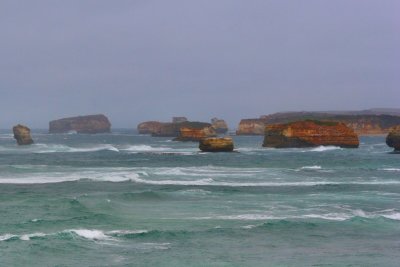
left=263, top=120, right=359, bottom=148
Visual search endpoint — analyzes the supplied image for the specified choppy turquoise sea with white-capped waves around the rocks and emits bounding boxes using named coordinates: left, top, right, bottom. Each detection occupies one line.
left=0, top=130, right=400, bottom=266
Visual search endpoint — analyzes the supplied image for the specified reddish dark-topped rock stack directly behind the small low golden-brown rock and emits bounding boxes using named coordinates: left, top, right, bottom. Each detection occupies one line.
left=174, top=122, right=217, bottom=141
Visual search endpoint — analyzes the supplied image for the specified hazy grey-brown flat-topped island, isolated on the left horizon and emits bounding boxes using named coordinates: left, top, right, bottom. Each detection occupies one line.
left=49, top=114, right=111, bottom=134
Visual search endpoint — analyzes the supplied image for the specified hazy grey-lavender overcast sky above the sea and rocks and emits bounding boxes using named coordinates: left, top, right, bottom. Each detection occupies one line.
left=0, top=0, right=400, bottom=129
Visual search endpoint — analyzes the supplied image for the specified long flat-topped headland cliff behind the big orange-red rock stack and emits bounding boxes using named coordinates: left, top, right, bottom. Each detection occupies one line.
left=236, top=110, right=400, bottom=135
